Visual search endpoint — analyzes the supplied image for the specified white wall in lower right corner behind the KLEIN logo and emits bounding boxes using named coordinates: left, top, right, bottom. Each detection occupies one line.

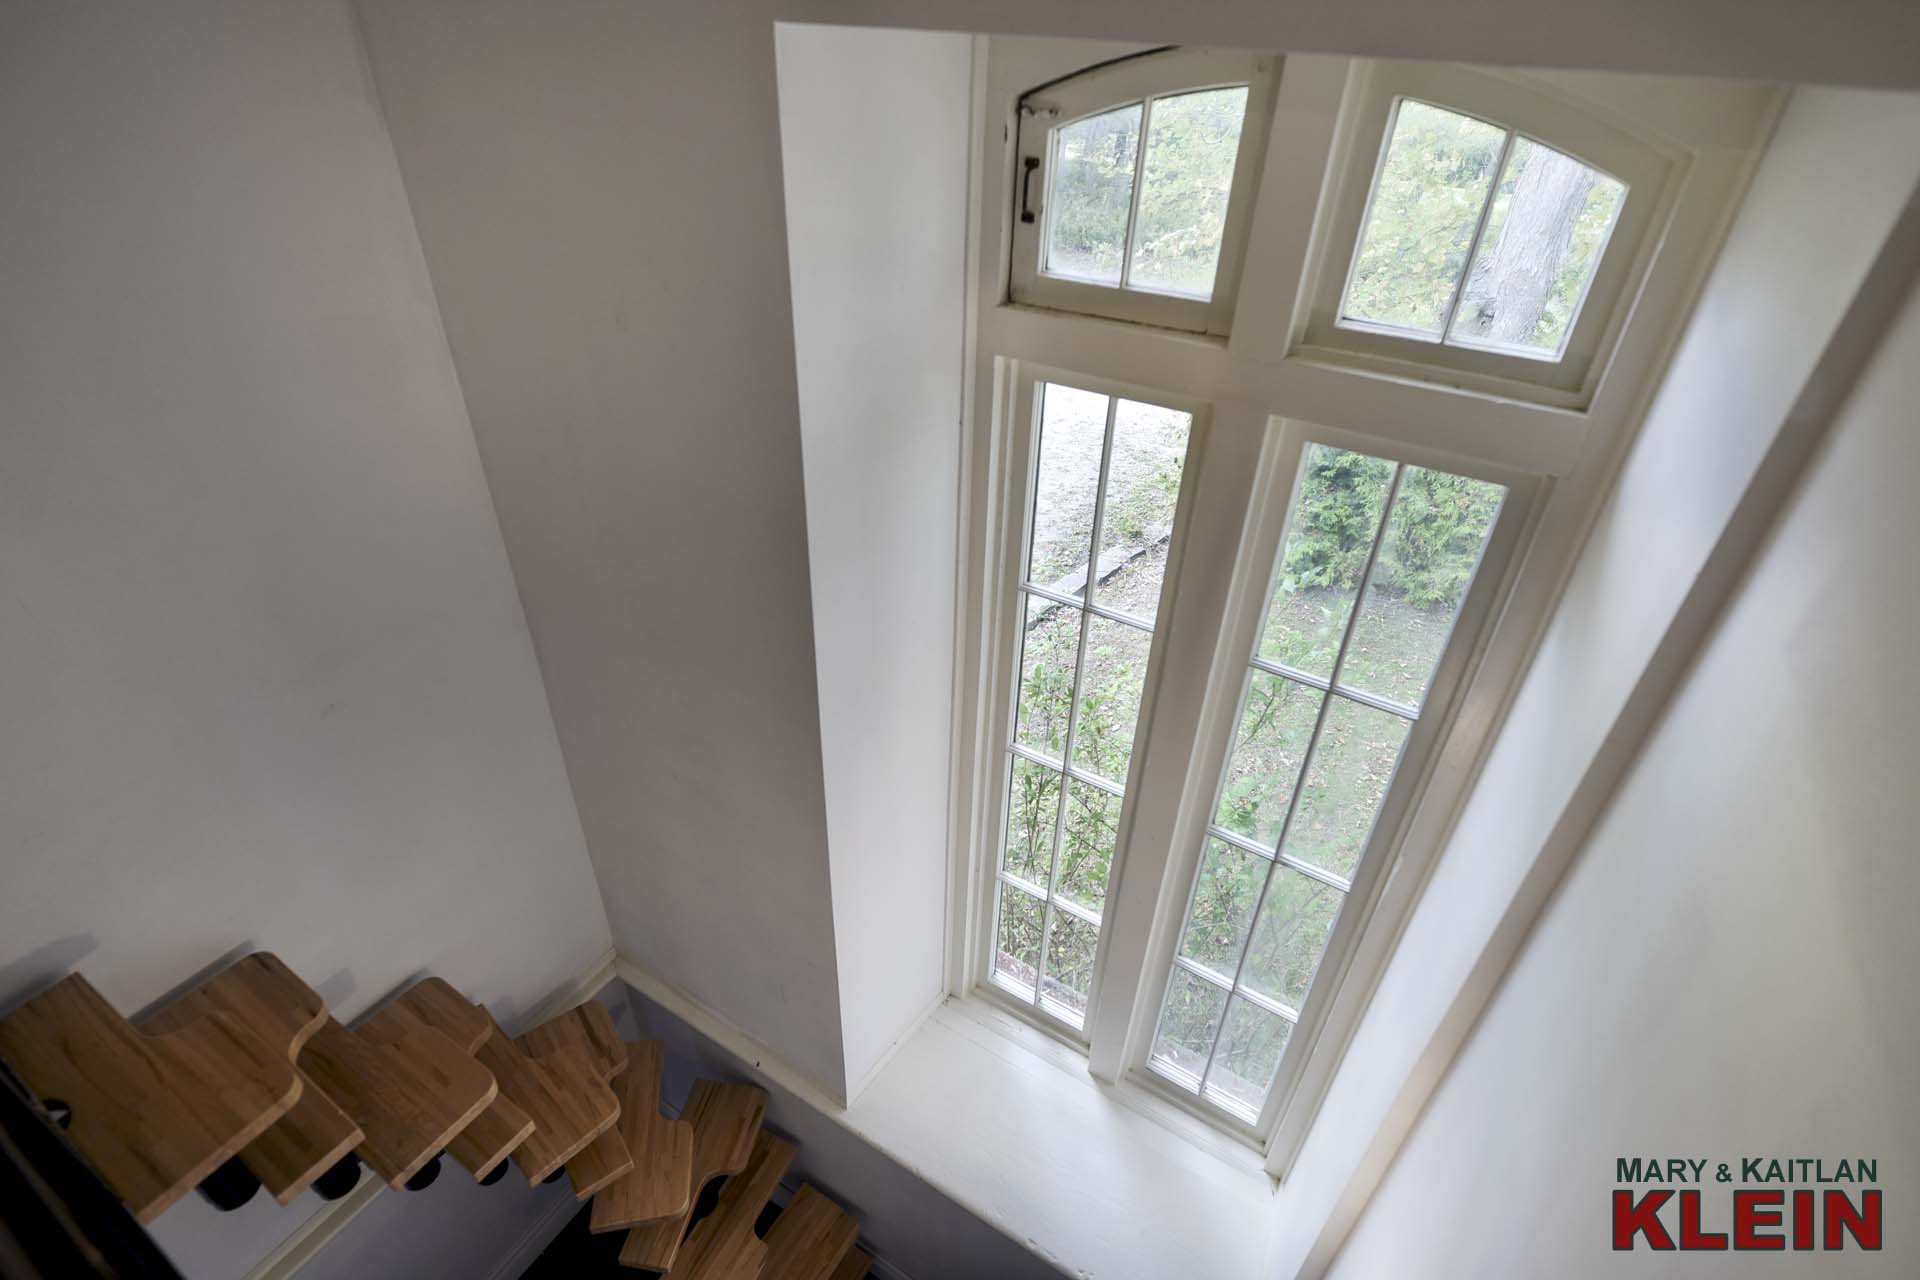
left=1332, top=264, right=1920, bottom=1276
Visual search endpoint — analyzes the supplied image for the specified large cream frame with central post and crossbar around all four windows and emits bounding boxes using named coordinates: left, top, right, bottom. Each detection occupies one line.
left=947, top=36, right=1782, bottom=1178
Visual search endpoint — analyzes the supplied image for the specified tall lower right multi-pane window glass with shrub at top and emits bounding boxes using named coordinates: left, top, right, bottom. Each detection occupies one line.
left=1148, top=443, right=1505, bottom=1125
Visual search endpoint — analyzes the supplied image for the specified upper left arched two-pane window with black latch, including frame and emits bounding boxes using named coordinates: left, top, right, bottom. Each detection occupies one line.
left=1010, top=50, right=1273, bottom=332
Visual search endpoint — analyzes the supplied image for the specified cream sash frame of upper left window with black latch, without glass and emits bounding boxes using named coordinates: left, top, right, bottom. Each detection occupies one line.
left=1006, top=48, right=1279, bottom=334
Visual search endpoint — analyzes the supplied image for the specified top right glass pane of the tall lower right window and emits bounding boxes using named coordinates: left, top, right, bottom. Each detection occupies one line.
left=1340, top=466, right=1505, bottom=708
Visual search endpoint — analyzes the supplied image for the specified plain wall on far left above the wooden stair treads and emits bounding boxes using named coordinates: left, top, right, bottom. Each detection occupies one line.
left=0, top=0, right=609, bottom=1051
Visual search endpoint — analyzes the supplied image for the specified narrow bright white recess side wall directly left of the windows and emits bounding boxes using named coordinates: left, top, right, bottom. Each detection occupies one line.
left=776, top=25, right=972, bottom=1088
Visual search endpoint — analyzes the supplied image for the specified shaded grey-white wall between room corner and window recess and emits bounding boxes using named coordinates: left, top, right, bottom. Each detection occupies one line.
left=361, top=0, right=845, bottom=1105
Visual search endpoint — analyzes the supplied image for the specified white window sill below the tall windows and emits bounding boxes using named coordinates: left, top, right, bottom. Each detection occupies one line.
left=841, top=996, right=1275, bottom=1280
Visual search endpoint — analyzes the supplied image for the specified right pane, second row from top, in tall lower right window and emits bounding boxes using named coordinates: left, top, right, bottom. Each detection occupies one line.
left=1286, top=697, right=1413, bottom=879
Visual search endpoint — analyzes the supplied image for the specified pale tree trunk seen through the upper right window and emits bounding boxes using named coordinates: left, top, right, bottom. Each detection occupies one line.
left=1455, top=146, right=1594, bottom=347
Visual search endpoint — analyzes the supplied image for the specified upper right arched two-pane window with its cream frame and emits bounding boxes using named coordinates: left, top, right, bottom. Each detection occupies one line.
left=1296, top=63, right=1678, bottom=407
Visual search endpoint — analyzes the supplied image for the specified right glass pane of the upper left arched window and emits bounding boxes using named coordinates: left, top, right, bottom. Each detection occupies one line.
left=1127, top=84, right=1246, bottom=297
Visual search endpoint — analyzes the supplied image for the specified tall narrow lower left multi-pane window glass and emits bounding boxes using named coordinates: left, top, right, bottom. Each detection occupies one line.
left=993, top=382, right=1192, bottom=1031
